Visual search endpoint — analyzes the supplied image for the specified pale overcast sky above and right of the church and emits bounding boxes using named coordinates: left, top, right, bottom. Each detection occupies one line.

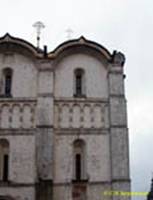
left=0, top=0, right=153, bottom=199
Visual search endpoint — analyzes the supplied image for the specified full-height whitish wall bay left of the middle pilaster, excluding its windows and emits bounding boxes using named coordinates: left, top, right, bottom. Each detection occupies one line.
left=0, top=52, right=37, bottom=200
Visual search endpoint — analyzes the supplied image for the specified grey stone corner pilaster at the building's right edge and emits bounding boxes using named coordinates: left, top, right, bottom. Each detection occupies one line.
left=108, top=52, right=130, bottom=200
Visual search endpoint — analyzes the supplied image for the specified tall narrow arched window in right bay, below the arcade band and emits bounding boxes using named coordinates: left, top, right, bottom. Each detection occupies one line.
left=73, top=140, right=85, bottom=181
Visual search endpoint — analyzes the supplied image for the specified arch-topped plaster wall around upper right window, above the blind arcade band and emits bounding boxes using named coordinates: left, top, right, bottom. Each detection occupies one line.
left=55, top=53, right=108, bottom=98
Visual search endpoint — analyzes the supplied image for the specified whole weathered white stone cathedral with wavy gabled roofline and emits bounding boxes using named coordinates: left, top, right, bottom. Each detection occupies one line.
left=0, top=34, right=130, bottom=200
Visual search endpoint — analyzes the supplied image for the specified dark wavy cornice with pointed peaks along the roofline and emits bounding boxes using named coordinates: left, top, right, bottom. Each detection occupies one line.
left=0, top=33, right=125, bottom=66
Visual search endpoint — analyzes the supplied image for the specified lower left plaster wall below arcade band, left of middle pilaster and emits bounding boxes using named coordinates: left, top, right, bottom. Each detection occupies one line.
left=0, top=135, right=36, bottom=184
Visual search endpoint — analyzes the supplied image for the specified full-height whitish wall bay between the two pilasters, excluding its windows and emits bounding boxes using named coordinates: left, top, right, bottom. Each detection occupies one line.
left=53, top=50, right=111, bottom=200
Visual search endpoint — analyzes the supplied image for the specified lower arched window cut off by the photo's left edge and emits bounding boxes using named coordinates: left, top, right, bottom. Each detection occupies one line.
left=0, top=139, right=9, bottom=182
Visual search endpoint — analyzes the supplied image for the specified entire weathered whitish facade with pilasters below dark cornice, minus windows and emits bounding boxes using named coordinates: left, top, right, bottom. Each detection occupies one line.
left=0, top=38, right=130, bottom=200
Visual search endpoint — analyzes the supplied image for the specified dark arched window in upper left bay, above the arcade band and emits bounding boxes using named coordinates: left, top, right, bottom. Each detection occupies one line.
left=3, top=68, right=12, bottom=97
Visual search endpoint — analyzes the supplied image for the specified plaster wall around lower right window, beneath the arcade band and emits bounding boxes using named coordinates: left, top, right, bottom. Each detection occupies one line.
left=54, top=134, right=110, bottom=183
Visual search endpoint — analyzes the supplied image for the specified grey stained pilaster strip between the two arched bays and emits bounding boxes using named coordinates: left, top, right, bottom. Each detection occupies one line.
left=36, top=61, right=54, bottom=200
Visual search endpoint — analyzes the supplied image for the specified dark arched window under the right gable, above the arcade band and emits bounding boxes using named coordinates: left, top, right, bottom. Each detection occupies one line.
left=74, top=69, right=85, bottom=97
